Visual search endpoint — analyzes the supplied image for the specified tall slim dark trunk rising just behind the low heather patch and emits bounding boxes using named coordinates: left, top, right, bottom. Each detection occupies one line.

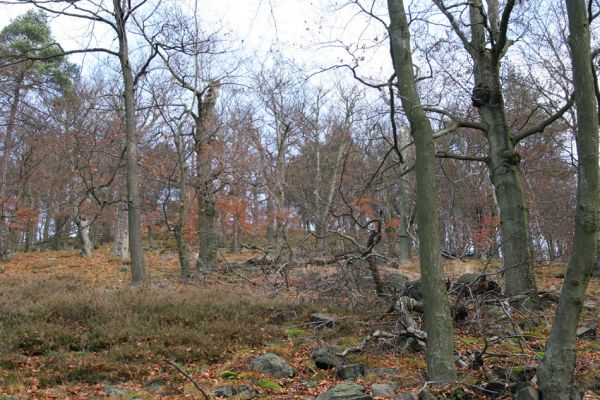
left=113, top=0, right=148, bottom=285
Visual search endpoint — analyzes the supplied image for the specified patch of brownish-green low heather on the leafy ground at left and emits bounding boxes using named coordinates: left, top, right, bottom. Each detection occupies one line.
left=0, top=275, right=300, bottom=386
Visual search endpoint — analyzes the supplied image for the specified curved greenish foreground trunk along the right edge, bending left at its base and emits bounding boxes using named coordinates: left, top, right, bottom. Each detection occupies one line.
left=537, top=0, right=600, bottom=400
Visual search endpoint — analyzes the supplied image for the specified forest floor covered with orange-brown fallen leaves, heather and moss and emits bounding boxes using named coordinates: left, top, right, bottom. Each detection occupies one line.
left=0, top=247, right=600, bottom=399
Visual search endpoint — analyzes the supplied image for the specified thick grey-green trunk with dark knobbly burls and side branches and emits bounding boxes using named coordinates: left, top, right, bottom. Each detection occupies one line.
left=469, top=0, right=537, bottom=296
